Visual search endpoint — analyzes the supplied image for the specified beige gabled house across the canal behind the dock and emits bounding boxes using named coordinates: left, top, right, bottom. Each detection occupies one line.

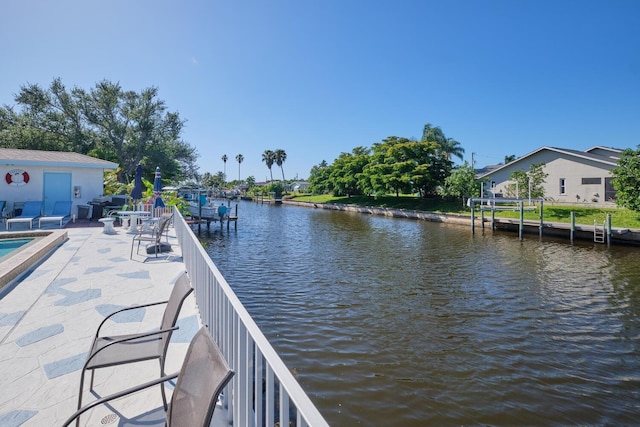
left=478, top=146, right=622, bottom=203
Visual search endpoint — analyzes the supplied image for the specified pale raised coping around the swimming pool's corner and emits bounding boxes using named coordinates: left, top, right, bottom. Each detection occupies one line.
left=0, top=230, right=67, bottom=291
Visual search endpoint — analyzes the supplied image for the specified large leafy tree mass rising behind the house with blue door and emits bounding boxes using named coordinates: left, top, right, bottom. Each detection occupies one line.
left=0, top=78, right=197, bottom=182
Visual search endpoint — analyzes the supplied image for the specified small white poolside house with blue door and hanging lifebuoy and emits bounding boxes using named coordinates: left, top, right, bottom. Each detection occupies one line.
left=0, top=148, right=118, bottom=214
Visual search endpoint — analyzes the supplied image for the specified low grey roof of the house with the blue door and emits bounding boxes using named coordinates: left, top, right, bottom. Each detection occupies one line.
left=0, top=148, right=118, bottom=169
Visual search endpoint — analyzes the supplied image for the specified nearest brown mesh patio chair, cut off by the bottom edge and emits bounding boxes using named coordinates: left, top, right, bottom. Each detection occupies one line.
left=63, top=326, right=234, bottom=427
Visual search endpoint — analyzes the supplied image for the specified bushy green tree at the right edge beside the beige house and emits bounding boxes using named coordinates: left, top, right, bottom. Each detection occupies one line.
left=611, top=145, right=640, bottom=212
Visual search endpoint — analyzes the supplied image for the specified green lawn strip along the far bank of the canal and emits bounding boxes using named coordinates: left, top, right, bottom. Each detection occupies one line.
left=294, top=195, right=640, bottom=229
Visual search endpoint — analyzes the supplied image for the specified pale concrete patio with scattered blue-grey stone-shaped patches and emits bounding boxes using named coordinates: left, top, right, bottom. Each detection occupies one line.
left=0, top=224, right=200, bottom=427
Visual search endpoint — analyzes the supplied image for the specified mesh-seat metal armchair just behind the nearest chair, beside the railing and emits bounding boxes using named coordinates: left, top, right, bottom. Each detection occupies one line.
left=78, top=272, right=193, bottom=416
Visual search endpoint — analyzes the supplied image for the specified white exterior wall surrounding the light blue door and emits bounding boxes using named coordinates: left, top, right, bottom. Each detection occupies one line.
left=0, top=165, right=104, bottom=214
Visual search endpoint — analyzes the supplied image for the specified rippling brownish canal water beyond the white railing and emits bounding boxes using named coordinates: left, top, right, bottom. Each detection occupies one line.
left=200, top=202, right=640, bottom=426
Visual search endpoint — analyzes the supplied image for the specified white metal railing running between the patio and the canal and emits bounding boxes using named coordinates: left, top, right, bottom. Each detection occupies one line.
left=174, top=209, right=328, bottom=427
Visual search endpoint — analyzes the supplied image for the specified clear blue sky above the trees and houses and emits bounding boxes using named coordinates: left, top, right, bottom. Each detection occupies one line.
left=0, top=0, right=640, bottom=181
